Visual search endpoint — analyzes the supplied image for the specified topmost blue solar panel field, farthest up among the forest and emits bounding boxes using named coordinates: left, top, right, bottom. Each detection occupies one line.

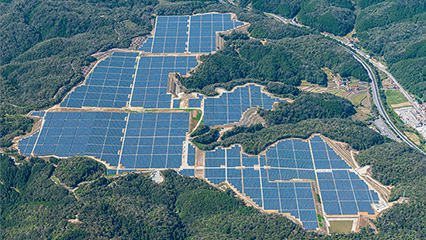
left=139, top=13, right=243, bottom=53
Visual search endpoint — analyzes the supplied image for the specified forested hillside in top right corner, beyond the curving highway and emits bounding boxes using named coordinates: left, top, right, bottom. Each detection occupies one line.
left=355, top=0, right=426, bottom=101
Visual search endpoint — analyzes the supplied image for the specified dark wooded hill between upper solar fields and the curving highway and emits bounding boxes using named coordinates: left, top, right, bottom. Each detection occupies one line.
left=180, top=35, right=368, bottom=95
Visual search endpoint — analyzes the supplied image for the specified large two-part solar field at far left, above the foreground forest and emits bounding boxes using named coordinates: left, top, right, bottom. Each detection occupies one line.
left=19, top=112, right=189, bottom=169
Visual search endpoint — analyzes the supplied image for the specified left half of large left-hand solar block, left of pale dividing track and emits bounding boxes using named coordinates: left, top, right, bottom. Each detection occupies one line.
left=19, top=112, right=128, bottom=166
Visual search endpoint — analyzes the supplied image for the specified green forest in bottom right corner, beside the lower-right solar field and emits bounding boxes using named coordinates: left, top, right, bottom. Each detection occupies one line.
left=356, top=143, right=426, bottom=239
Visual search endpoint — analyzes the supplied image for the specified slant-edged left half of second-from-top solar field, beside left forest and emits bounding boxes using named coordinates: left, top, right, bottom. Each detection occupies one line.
left=61, top=52, right=138, bottom=108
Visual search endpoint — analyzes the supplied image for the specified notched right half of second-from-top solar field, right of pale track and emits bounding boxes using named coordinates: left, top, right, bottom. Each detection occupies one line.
left=130, top=56, right=198, bottom=108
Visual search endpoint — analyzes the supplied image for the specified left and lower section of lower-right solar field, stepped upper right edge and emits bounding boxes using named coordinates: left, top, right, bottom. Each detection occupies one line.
left=201, top=146, right=318, bottom=230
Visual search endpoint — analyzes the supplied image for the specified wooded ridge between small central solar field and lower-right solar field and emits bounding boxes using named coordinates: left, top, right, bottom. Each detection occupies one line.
left=193, top=93, right=382, bottom=155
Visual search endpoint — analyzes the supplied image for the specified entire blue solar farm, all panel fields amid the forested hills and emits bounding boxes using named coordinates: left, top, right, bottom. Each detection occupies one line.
left=18, top=13, right=379, bottom=230
